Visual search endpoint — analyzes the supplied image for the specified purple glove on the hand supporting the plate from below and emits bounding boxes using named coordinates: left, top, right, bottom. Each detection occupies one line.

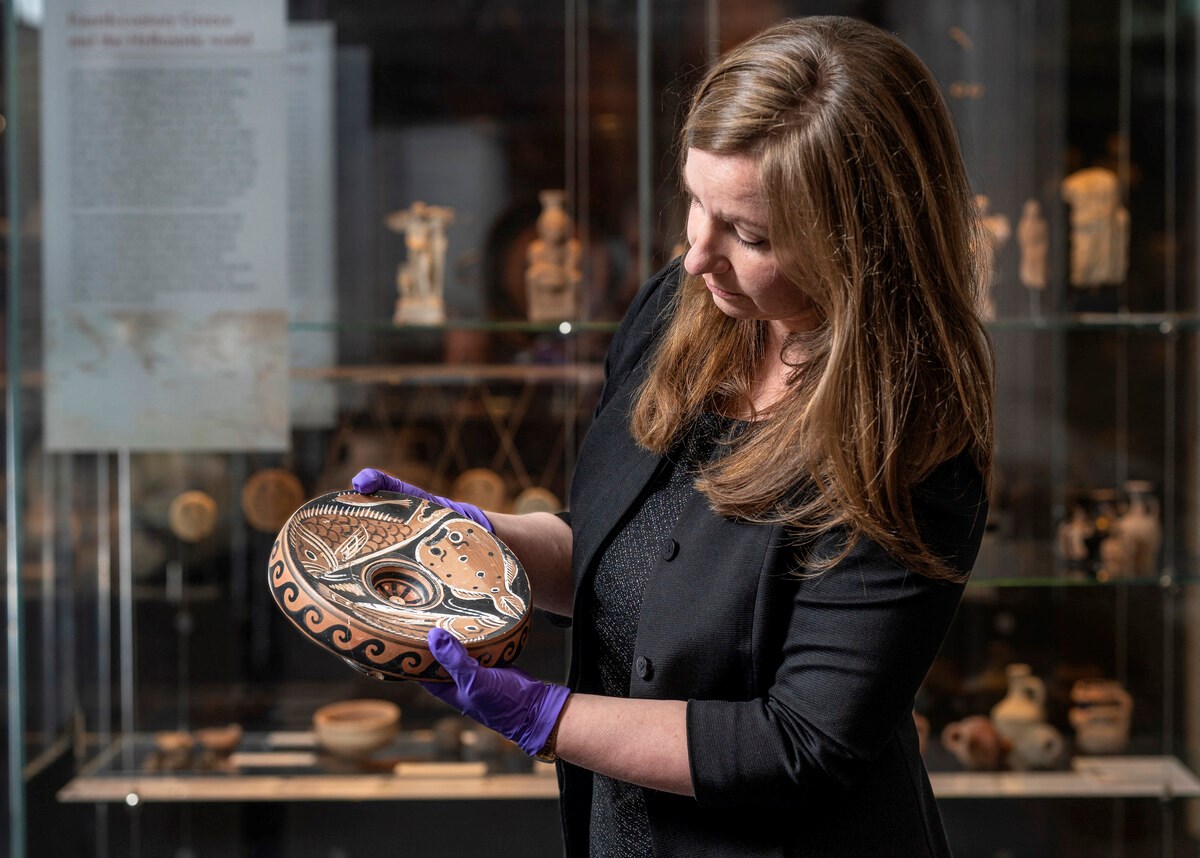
left=421, top=629, right=571, bottom=756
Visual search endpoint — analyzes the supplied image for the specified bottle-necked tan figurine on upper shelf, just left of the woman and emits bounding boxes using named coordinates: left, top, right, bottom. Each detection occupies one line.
left=526, top=191, right=581, bottom=322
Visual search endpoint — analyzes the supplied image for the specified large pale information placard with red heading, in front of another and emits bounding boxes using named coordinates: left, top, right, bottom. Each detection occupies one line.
left=42, top=0, right=289, bottom=450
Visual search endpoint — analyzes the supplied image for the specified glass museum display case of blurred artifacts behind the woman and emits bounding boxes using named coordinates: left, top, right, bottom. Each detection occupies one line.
left=0, top=0, right=1200, bottom=858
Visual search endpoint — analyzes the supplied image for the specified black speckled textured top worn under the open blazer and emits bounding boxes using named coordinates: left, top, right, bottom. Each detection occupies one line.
left=584, top=414, right=737, bottom=858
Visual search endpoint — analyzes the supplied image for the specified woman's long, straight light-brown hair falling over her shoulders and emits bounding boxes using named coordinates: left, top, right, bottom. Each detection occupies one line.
left=632, top=17, right=994, bottom=578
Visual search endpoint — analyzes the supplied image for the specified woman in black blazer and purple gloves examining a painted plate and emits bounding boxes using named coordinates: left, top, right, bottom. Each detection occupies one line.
left=355, top=18, right=992, bottom=856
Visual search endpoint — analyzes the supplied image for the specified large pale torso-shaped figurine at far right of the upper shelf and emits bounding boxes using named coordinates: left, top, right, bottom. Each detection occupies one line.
left=1062, top=167, right=1129, bottom=288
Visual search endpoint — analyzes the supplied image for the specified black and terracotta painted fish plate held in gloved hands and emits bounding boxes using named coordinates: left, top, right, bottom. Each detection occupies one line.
left=268, top=492, right=532, bottom=682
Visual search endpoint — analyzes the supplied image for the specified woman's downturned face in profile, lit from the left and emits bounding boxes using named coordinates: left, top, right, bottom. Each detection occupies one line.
left=683, top=149, right=817, bottom=332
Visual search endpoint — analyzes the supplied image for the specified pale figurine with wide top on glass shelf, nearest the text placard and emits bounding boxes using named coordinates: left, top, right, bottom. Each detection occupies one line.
left=385, top=202, right=454, bottom=325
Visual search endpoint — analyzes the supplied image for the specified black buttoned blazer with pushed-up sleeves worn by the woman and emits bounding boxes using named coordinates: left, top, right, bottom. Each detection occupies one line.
left=559, top=260, right=986, bottom=858
